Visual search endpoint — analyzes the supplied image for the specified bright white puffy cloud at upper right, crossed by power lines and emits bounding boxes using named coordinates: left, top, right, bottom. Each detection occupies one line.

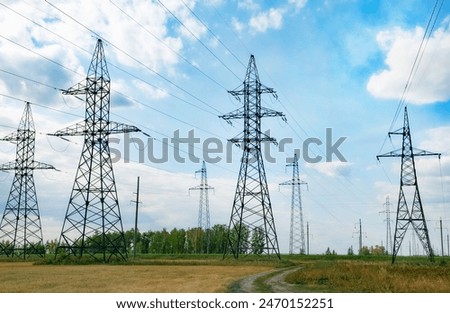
left=367, top=22, right=450, bottom=104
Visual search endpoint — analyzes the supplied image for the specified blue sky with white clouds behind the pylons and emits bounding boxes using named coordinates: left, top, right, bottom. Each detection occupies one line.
left=0, top=0, right=450, bottom=254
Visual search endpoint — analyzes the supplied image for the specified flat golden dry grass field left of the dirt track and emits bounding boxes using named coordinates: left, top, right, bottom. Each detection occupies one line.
left=0, top=262, right=273, bottom=293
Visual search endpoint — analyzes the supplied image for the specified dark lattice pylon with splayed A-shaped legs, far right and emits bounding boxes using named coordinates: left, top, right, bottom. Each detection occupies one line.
left=377, top=106, right=441, bottom=263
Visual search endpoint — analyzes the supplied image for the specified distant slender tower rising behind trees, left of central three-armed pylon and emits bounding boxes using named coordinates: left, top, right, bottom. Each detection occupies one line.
left=189, top=161, right=214, bottom=253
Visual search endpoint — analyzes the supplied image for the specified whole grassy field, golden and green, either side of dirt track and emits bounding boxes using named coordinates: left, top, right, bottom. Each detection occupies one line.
left=0, top=255, right=450, bottom=293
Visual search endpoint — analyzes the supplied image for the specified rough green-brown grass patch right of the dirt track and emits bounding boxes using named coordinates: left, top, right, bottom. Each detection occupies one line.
left=286, top=261, right=450, bottom=293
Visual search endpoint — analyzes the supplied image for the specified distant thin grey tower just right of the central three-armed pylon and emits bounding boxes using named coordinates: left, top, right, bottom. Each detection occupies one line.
left=280, top=154, right=307, bottom=254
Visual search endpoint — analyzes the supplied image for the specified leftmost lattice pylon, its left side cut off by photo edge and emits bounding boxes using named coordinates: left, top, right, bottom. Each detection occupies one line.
left=0, top=102, right=55, bottom=259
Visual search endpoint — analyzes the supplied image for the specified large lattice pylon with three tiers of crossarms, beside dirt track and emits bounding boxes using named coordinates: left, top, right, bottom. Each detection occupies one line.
left=220, top=55, right=285, bottom=258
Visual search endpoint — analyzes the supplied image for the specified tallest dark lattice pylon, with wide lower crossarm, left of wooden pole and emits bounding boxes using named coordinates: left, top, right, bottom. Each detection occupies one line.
left=52, top=39, right=140, bottom=262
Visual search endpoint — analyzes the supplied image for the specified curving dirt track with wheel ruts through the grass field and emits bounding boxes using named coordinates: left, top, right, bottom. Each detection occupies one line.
left=235, top=266, right=300, bottom=293
